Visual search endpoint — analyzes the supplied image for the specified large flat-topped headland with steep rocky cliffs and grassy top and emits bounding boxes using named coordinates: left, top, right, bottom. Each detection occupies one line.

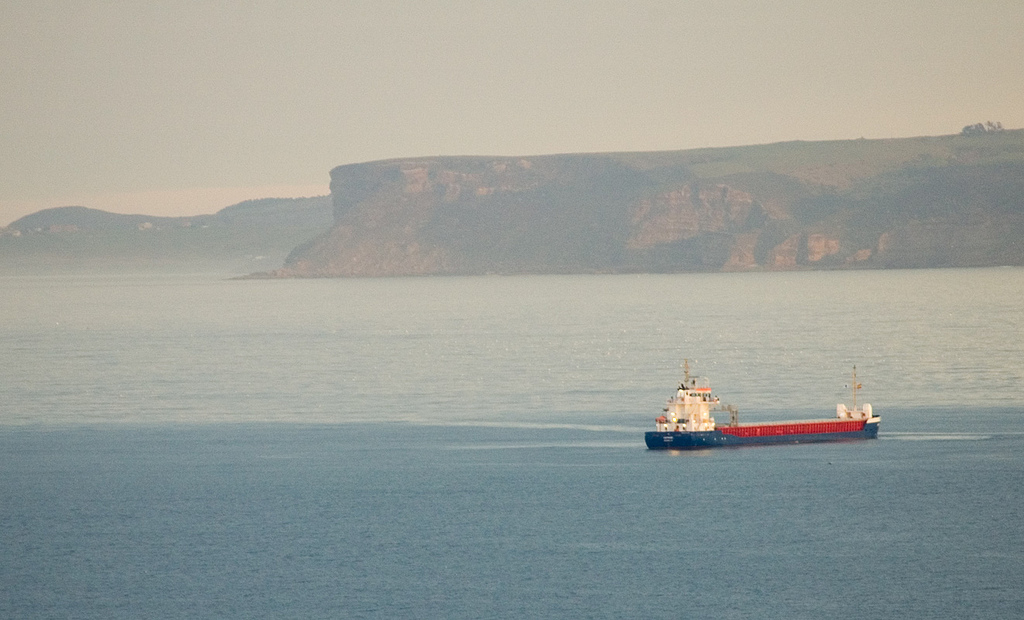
left=271, top=131, right=1024, bottom=277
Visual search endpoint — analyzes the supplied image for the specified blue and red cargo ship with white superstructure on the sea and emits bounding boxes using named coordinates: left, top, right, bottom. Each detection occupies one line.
left=644, top=362, right=882, bottom=450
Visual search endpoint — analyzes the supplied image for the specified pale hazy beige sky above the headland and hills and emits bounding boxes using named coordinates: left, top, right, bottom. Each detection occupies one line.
left=0, top=0, right=1024, bottom=225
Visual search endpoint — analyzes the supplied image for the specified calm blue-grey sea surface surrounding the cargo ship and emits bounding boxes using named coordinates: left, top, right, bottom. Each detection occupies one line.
left=0, top=267, right=1024, bottom=619
